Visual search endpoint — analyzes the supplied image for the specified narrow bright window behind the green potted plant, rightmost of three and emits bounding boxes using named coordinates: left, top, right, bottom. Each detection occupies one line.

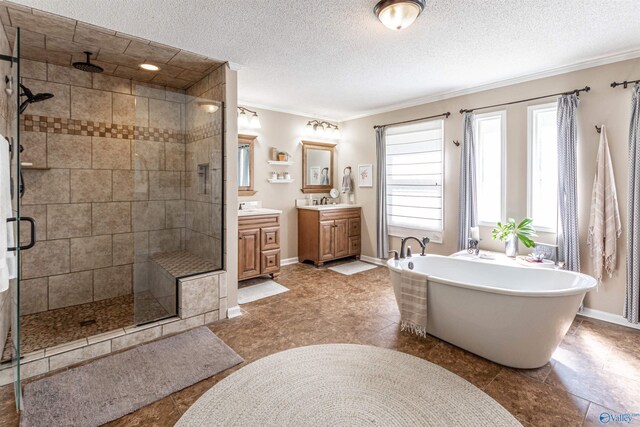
left=527, top=103, right=558, bottom=233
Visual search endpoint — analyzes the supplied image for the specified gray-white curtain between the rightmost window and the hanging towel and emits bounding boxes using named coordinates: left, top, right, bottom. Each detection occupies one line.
left=558, top=94, right=580, bottom=271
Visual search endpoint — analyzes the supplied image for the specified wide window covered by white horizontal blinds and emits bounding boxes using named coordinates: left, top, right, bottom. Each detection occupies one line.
left=386, top=120, right=444, bottom=243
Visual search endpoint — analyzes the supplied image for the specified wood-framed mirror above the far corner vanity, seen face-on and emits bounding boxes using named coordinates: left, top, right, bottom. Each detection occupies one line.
left=302, top=141, right=335, bottom=193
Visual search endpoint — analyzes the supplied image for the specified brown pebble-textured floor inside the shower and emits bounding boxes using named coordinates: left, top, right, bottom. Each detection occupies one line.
left=2, top=294, right=167, bottom=361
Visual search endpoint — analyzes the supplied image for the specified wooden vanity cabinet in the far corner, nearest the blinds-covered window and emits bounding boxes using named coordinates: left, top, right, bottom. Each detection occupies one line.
left=298, top=207, right=361, bottom=266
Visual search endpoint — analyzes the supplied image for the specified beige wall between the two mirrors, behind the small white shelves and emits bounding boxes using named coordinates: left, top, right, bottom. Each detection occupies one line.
left=239, top=108, right=338, bottom=259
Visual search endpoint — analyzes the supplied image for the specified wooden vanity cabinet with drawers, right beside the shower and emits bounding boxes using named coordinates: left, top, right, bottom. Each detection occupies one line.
left=238, top=215, right=280, bottom=280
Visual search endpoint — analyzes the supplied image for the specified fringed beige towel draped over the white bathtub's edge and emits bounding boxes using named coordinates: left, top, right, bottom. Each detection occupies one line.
left=400, top=269, right=428, bottom=337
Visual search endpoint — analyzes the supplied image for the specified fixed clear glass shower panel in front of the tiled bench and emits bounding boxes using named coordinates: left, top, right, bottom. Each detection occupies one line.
left=131, top=89, right=224, bottom=324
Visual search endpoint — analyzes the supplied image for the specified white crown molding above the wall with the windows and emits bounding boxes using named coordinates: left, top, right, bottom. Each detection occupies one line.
left=340, top=49, right=640, bottom=122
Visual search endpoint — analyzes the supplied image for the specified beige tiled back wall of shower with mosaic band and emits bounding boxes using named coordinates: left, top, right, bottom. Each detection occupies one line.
left=20, top=60, right=190, bottom=314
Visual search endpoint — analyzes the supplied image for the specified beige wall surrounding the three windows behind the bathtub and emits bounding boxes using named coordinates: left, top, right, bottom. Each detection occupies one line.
left=338, top=59, right=640, bottom=315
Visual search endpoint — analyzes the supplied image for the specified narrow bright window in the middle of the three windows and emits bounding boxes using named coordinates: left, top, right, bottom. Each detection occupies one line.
left=474, top=111, right=507, bottom=226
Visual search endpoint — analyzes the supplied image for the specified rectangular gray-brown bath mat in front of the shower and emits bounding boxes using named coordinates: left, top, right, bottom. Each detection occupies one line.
left=20, top=327, right=243, bottom=427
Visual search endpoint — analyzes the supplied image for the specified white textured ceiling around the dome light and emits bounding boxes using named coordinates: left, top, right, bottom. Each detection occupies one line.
left=5, top=0, right=640, bottom=119
